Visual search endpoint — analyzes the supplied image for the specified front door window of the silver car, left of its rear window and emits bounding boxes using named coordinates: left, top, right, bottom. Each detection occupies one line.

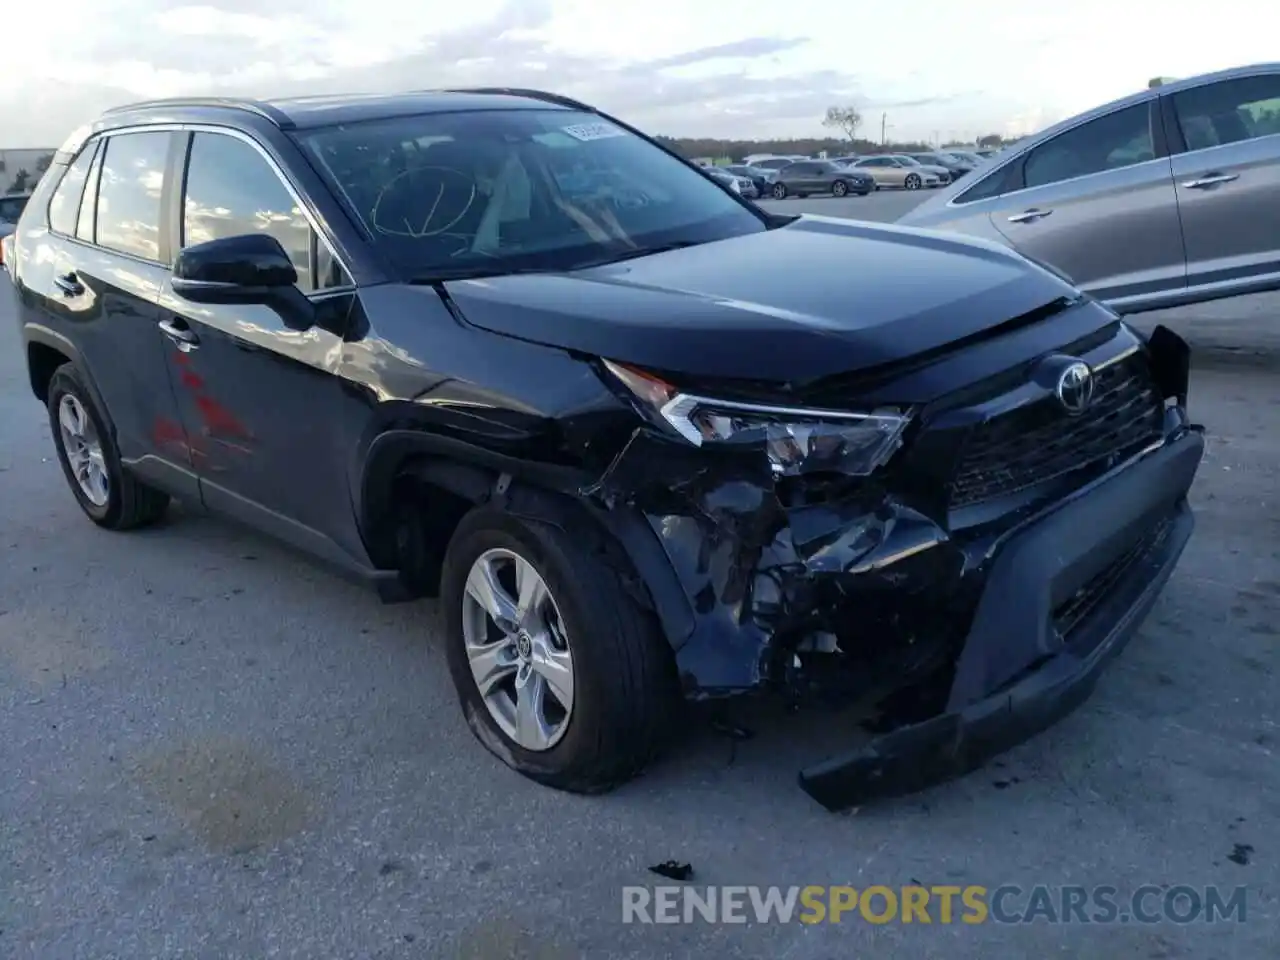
left=1023, top=102, right=1156, bottom=187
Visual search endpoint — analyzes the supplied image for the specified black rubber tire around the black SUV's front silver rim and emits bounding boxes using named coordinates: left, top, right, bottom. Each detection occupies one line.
left=440, top=507, right=682, bottom=794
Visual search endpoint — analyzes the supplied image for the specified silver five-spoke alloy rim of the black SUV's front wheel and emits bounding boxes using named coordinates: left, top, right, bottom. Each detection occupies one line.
left=462, top=548, right=575, bottom=753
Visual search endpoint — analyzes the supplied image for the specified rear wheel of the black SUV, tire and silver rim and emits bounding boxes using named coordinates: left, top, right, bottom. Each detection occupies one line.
left=47, top=364, right=169, bottom=530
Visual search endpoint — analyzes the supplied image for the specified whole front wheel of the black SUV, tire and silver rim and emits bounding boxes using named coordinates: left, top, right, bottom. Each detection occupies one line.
left=440, top=507, right=681, bottom=794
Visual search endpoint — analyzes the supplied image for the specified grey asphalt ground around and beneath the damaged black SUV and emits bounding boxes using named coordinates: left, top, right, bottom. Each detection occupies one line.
left=0, top=220, right=1280, bottom=960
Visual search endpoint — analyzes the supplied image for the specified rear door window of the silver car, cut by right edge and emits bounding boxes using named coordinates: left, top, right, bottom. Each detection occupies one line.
left=1171, top=74, right=1280, bottom=150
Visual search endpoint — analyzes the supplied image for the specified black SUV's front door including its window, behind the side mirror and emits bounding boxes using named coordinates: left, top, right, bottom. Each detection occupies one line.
left=160, top=132, right=362, bottom=564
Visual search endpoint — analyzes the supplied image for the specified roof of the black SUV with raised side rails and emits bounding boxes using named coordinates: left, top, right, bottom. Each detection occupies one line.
left=58, top=87, right=593, bottom=160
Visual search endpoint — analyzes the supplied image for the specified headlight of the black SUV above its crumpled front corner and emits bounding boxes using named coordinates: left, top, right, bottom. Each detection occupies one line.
left=604, top=360, right=910, bottom=476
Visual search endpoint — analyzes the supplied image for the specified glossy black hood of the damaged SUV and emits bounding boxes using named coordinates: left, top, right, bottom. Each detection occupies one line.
left=445, top=216, right=1075, bottom=383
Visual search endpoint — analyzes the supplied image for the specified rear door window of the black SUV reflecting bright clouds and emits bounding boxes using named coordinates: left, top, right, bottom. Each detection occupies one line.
left=97, top=132, right=170, bottom=261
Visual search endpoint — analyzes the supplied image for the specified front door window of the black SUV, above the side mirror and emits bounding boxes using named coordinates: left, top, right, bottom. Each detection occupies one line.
left=182, top=133, right=340, bottom=291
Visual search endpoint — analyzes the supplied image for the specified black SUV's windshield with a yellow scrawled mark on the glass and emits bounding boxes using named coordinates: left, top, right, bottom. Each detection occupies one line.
left=300, top=109, right=765, bottom=279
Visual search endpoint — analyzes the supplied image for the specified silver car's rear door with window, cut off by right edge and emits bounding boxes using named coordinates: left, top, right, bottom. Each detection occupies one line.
left=1164, top=73, right=1280, bottom=296
